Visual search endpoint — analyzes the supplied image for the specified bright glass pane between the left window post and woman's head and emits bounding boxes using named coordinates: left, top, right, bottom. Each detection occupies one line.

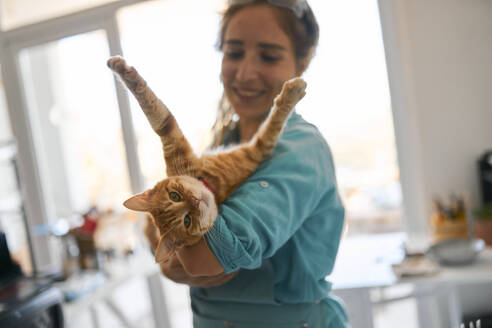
left=118, top=0, right=222, bottom=186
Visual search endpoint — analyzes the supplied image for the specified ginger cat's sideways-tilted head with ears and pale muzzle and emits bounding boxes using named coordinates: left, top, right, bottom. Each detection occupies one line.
left=123, top=176, right=217, bottom=262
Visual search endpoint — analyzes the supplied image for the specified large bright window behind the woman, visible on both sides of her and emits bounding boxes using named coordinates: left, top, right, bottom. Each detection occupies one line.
left=118, top=0, right=402, bottom=234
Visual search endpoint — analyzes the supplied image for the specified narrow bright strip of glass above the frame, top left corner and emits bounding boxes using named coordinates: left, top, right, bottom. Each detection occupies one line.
left=0, top=0, right=117, bottom=31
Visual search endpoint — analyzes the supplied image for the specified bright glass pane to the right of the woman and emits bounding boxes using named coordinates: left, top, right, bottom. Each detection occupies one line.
left=304, top=0, right=402, bottom=234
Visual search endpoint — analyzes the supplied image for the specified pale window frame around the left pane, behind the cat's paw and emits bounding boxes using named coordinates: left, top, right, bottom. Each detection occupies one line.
left=0, top=0, right=144, bottom=271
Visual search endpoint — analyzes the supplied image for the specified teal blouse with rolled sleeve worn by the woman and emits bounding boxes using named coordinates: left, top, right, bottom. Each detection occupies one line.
left=190, top=113, right=346, bottom=328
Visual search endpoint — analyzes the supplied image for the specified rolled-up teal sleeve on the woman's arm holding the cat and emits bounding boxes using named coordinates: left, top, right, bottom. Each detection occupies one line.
left=206, top=123, right=335, bottom=273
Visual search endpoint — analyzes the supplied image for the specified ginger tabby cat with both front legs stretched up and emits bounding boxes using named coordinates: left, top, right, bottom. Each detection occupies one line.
left=107, top=56, right=306, bottom=262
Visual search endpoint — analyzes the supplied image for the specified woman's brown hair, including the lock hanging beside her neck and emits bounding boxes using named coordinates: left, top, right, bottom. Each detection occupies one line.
left=212, top=0, right=319, bottom=147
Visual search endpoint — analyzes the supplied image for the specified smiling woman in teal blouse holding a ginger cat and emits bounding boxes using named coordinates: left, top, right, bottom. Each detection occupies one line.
left=152, top=0, right=348, bottom=328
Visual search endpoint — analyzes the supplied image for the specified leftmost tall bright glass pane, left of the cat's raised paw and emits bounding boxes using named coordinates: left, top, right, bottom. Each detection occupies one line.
left=20, top=31, right=130, bottom=217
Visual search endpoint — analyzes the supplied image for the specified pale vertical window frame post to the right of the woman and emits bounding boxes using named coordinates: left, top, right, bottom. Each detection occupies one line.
left=377, top=0, right=429, bottom=241
